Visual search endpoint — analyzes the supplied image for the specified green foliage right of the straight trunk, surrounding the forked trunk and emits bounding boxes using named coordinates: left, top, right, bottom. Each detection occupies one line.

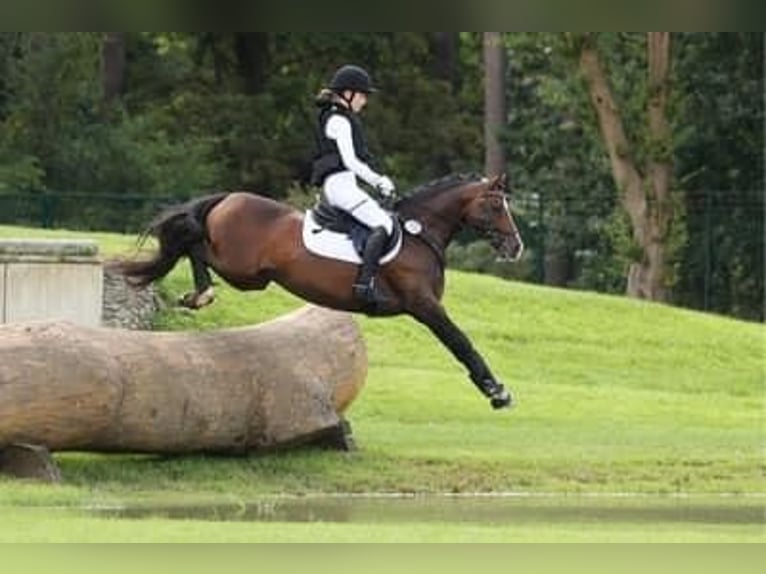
left=506, top=33, right=764, bottom=319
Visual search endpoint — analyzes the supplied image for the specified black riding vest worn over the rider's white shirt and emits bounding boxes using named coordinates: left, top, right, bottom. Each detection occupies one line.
left=311, top=102, right=375, bottom=187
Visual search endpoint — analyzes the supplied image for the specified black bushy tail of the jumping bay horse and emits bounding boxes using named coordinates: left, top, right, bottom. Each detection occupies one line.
left=112, top=193, right=228, bottom=287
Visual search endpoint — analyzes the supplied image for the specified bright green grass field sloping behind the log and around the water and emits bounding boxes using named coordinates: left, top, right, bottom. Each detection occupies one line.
left=0, top=227, right=766, bottom=541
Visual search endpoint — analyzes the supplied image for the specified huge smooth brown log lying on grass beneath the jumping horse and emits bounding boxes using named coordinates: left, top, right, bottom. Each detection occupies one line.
left=0, top=307, right=367, bottom=453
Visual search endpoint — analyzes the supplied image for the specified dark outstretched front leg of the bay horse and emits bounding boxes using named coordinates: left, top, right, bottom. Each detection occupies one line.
left=410, top=301, right=513, bottom=409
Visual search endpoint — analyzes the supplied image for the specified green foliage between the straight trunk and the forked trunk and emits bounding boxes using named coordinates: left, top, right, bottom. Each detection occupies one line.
left=506, top=33, right=621, bottom=292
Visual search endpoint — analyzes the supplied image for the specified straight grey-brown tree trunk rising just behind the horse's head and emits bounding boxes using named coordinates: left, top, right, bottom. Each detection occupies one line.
left=484, top=32, right=506, bottom=177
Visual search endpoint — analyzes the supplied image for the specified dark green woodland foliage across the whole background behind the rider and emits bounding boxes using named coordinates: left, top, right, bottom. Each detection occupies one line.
left=0, top=32, right=764, bottom=319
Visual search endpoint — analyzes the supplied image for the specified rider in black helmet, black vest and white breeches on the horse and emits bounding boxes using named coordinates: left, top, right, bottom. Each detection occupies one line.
left=312, top=65, right=394, bottom=304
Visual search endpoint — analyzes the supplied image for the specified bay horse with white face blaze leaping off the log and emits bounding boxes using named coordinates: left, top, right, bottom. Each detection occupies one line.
left=116, top=174, right=524, bottom=409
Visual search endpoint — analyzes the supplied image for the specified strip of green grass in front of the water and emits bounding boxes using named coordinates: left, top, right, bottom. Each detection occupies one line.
left=0, top=509, right=764, bottom=542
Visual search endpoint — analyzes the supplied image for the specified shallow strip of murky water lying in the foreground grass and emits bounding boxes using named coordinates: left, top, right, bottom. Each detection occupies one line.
left=89, top=495, right=766, bottom=525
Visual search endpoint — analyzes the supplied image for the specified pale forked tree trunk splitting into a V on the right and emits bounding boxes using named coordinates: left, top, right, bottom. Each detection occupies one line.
left=580, top=32, right=673, bottom=301
